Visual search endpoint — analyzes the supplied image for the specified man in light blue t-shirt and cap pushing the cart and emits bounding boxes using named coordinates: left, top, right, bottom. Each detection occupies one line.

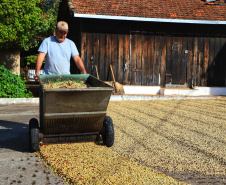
left=34, top=21, right=86, bottom=81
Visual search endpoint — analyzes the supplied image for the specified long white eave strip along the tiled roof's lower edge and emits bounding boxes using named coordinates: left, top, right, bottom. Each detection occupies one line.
left=74, top=13, right=226, bottom=25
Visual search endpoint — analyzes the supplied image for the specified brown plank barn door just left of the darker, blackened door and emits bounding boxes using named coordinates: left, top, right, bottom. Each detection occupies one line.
left=130, top=33, right=162, bottom=86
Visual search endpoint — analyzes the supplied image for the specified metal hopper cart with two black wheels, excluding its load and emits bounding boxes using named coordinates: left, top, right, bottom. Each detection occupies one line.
left=29, top=74, right=114, bottom=152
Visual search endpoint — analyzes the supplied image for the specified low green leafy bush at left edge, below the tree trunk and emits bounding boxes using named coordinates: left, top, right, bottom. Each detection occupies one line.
left=0, top=65, right=32, bottom=98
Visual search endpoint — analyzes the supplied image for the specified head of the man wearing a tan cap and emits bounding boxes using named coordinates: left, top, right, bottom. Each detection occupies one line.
left=55, top=21, right=68, bottom=42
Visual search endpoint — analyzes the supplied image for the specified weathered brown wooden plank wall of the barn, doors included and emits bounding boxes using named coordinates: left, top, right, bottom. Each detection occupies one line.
left=81, top=32, right=226, bottom=86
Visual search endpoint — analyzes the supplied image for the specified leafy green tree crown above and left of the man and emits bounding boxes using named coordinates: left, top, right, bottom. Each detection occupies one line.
left=0, top=0, right=59, bottom=51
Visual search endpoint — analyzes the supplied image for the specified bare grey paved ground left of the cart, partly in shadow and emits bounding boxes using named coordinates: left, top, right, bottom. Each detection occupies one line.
left=0, top=103, right=66, bottom=185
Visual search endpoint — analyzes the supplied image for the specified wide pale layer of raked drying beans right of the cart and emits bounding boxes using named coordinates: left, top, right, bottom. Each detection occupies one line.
left=108, top=98, right=226, bottom=184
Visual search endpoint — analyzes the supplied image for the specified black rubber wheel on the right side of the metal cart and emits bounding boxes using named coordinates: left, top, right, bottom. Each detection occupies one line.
left=102, top=116, right=115, bottom=147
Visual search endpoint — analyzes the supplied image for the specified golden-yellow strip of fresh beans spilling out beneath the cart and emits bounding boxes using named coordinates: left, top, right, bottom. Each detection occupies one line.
left=37, top=143, right=186, bottom=185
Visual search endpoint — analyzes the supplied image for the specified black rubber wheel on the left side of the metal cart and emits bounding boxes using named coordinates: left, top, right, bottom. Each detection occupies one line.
left=29, top=118, right=39, bottom=152
